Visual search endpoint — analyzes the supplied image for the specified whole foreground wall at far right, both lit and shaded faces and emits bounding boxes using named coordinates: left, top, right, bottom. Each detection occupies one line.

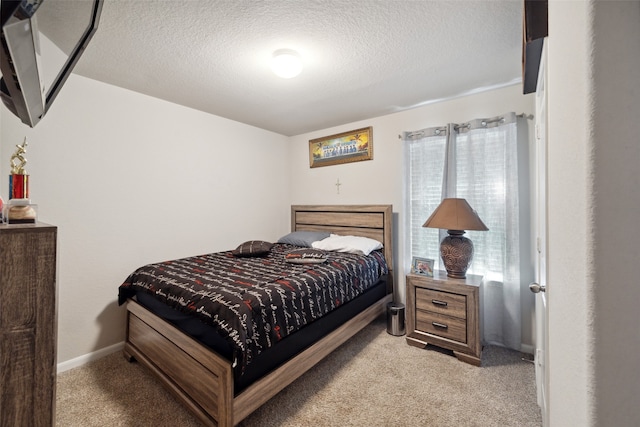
left=548, top=0, right=640, bottom=426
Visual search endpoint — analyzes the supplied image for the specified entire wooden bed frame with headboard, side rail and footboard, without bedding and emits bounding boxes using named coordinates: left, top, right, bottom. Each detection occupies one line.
left=124, top=205, right=393, bottom=427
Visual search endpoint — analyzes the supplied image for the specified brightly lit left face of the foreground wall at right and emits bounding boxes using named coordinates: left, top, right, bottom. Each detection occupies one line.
left=546, top=1, right=596, bottom=426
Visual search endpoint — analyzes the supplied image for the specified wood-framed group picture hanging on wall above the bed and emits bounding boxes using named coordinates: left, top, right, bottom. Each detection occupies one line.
left=309, top=126, right=373, bottom=168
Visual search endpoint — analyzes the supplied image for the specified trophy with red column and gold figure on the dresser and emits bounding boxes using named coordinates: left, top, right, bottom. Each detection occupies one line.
left=3, top=138, right=37, bottom=224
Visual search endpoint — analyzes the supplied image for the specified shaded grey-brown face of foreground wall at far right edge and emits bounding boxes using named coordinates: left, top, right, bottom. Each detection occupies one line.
left=591, top=1, right=640, bottom=425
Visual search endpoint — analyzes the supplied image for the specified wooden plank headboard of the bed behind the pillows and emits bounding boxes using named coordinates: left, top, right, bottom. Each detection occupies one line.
left=291, top=205, right=393, bottom=288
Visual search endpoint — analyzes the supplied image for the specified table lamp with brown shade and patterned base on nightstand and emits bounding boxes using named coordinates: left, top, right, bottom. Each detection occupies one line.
left=422, top=199, right=489, bottom=279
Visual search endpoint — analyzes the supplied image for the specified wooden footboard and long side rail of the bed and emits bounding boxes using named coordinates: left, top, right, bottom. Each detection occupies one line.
left=124, top=294, right=392, bottom=426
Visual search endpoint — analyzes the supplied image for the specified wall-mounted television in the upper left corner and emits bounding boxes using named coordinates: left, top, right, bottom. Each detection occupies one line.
left=0, top=0, right=104, bottom=127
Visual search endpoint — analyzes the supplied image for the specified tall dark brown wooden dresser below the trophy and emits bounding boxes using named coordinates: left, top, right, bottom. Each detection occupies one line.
left=0, top=224, right=57, bottom=427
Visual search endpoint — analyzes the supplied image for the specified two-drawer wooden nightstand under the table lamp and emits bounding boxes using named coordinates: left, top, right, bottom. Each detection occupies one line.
left=406, top=270, right=482, bottom=366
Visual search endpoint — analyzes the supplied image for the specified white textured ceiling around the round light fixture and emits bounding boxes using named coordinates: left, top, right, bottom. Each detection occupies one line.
left=67, top=0, right=522, bottom=136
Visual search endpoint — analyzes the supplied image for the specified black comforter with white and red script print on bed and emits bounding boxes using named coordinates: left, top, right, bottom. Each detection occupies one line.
left=118, top=244, right=387, bottom=372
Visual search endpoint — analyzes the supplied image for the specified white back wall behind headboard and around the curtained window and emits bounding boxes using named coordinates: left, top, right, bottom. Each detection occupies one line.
left=289, top=85, right=535, bottom=351
